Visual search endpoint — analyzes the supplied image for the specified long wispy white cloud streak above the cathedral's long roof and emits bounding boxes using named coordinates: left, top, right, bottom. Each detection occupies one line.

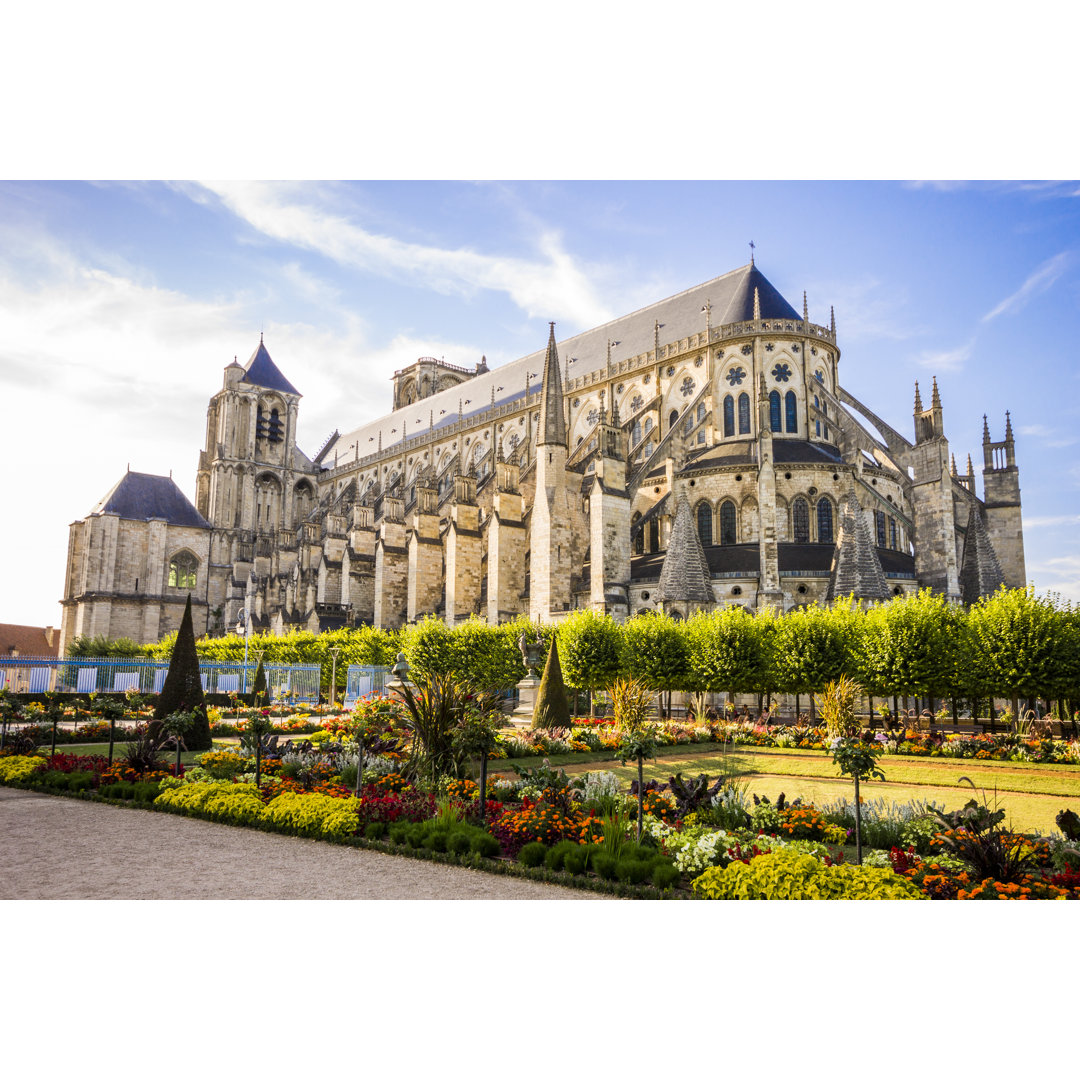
left=183, top=183, right=612, bottom=326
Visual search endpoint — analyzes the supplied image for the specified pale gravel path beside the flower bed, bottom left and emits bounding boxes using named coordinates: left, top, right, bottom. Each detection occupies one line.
left=0, top=787, right=609, bottom=900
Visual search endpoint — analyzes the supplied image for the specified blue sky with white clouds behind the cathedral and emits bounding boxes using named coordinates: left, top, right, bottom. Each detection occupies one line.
left=0, top=181, right=1080, bottom=624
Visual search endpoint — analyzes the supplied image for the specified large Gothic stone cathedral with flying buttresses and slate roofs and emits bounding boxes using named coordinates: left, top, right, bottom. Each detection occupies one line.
left=54, top=261, right=1026, bottom=648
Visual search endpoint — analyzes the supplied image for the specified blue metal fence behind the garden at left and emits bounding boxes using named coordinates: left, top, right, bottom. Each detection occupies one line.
left=0, top=657, right=322, bottom=702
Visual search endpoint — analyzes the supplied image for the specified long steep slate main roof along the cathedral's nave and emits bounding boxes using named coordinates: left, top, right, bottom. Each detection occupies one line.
left=330, top=264, right=802, bottom=459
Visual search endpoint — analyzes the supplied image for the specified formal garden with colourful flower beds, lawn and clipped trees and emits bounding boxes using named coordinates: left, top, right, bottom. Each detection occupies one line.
left=6, top=591, right=1080, bottom=900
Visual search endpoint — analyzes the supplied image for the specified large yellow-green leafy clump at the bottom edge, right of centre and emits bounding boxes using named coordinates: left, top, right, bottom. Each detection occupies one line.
left=691, top=848, right=926, bottom=900
